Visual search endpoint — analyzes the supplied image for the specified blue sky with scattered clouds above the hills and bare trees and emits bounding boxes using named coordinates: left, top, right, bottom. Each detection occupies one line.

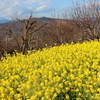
left=0, top=0, right=99, bottom=19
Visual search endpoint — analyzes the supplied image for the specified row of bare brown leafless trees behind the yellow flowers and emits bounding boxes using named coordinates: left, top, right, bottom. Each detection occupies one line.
left=0, top=0, right=100, bottom=56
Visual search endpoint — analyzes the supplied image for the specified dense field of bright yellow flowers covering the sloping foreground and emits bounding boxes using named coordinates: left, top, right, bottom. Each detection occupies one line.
left=0, top=41, right=100, bottom=100
